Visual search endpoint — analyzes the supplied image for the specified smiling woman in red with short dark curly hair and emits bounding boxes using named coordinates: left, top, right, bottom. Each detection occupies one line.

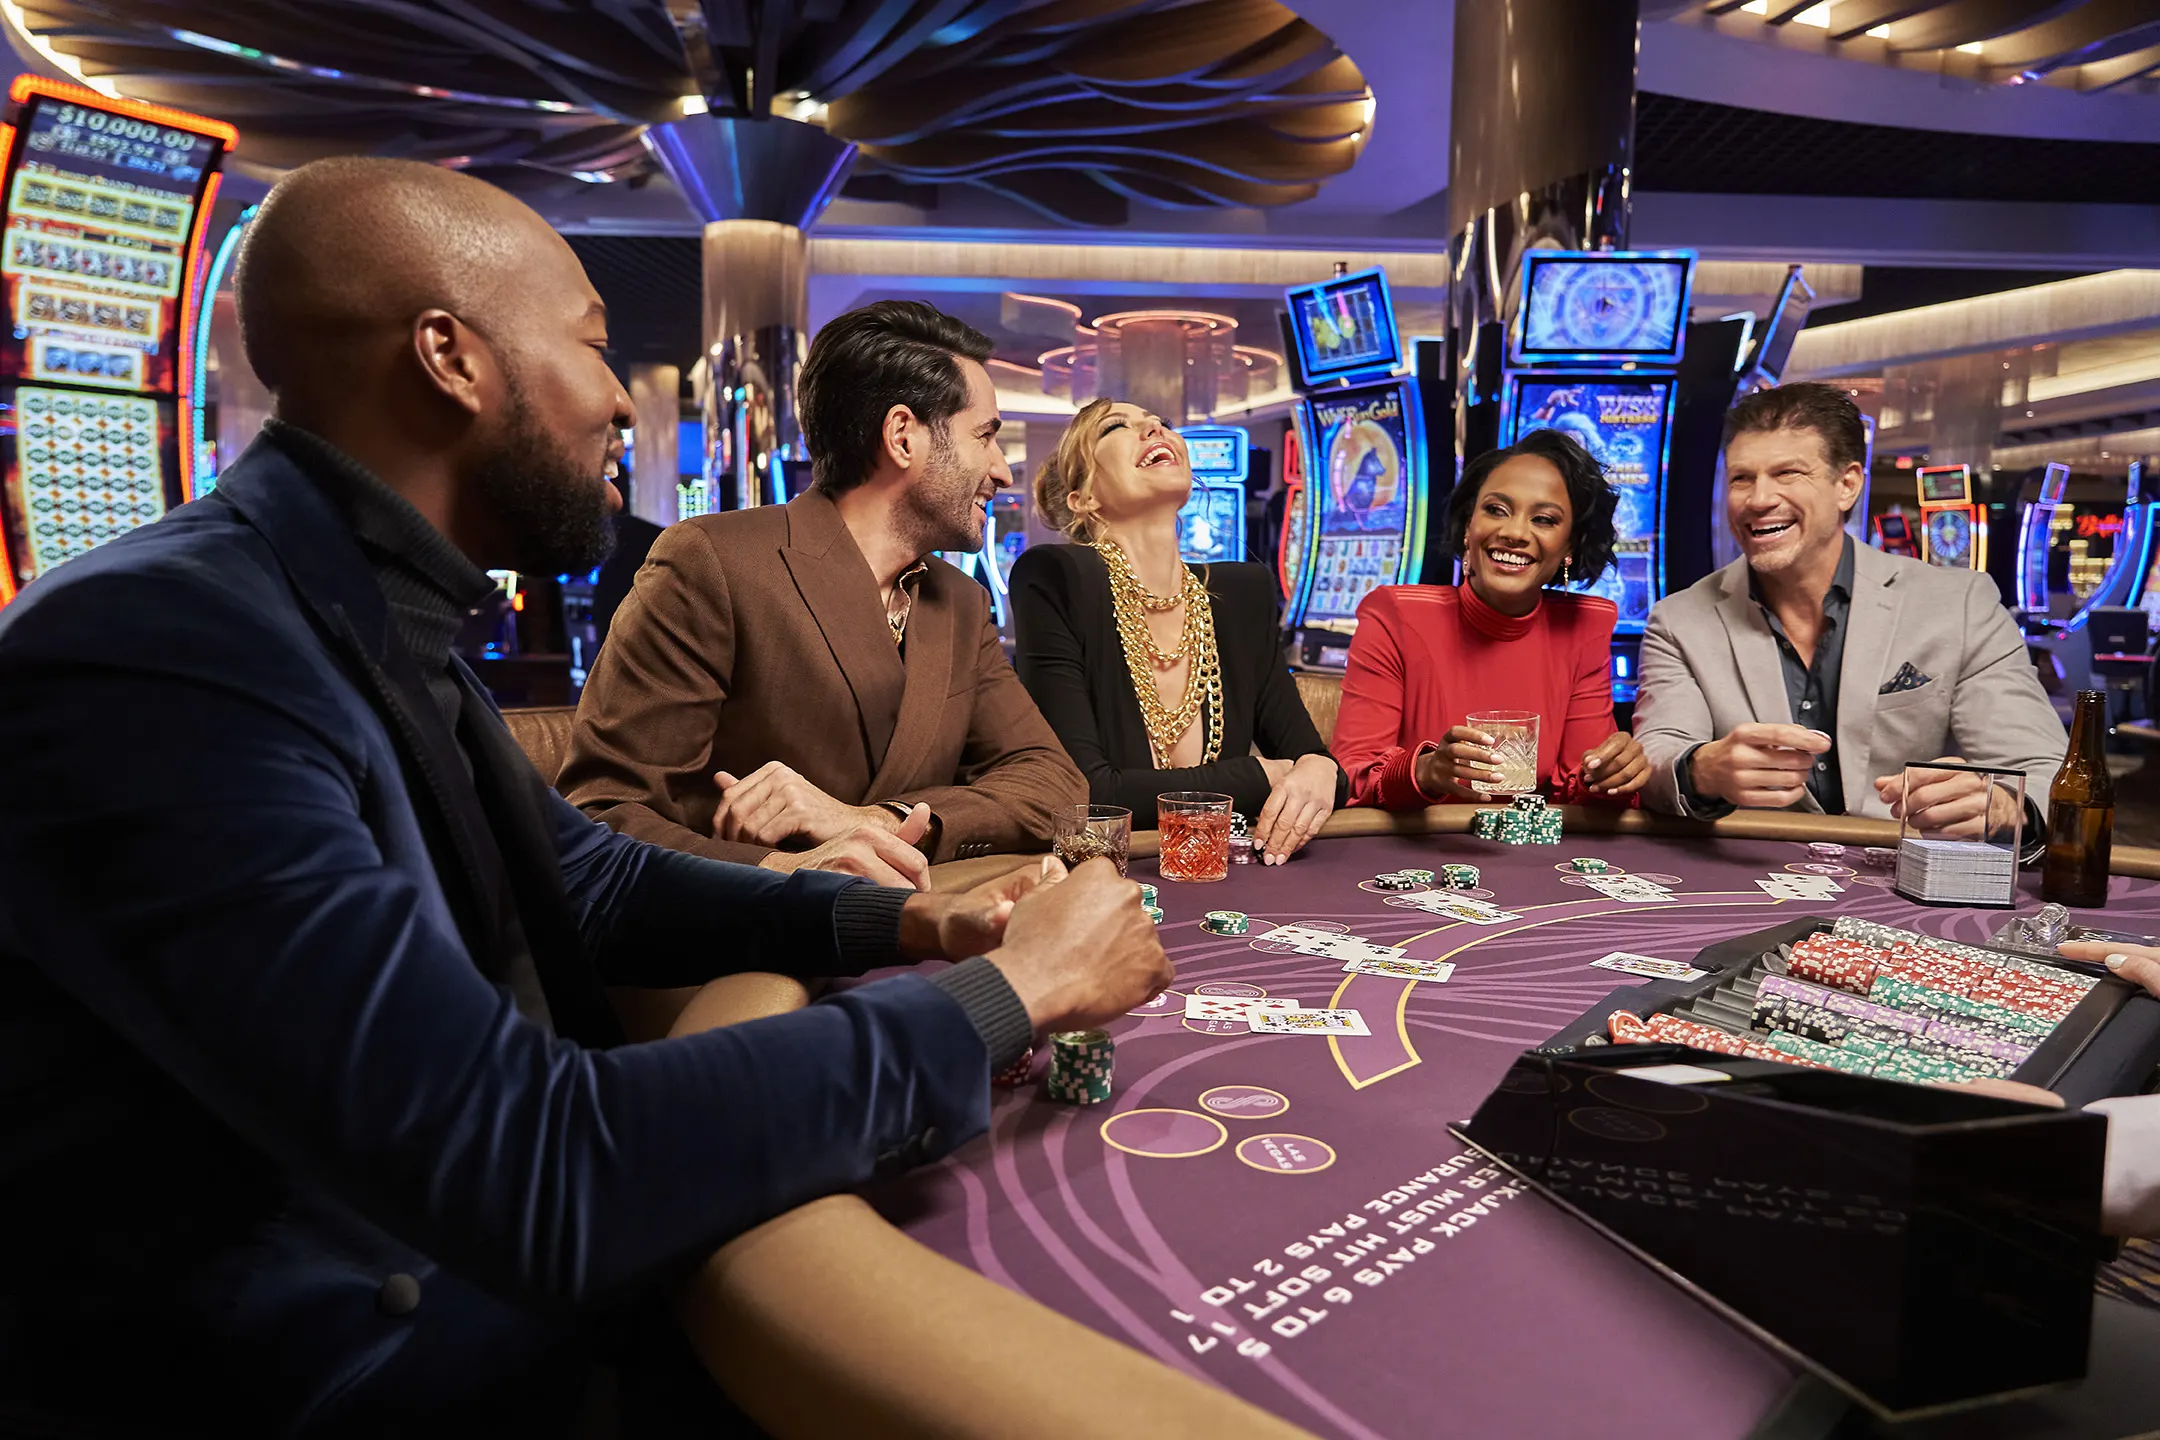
left=1333, top=430, right=1650, bottom=810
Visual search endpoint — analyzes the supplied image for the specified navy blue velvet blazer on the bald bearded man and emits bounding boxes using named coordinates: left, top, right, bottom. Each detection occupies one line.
left=0, top=440, right=989, bottom=1434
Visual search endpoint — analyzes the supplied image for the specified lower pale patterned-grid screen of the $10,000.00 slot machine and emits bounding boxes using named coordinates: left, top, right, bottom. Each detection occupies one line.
left=6, top=384, right=173, bottom=581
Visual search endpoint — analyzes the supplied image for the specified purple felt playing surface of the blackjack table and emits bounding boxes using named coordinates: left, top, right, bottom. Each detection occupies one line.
left=877, top=836, right=2160, bottom=1440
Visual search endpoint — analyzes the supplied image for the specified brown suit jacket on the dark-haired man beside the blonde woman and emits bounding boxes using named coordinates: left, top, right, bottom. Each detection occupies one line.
left=555, top=490, right=1086, bottom=864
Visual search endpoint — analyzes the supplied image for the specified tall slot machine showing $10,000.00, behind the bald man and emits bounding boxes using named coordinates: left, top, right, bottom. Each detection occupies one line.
left=0, top=76, right=238, bottom=604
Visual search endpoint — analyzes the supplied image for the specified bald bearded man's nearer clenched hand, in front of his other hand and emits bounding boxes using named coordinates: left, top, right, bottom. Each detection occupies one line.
left=989, top=857, right=1177, bottom=1036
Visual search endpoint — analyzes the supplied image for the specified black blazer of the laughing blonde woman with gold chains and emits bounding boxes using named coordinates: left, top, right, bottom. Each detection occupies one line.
left=1011, top=544, right=1348, bottom=829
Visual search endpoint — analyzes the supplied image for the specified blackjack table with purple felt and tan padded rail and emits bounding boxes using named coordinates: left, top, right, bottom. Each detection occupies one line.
left=685, top=807, right=2160, bottom=1440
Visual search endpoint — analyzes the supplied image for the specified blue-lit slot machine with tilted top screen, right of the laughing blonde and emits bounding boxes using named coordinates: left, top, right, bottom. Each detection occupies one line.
left=1283, top=270, right=1430, bottom=669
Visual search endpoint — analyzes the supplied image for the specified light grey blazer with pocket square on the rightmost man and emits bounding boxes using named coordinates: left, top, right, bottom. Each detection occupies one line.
left=1635, top=546, right=2069, bottom=818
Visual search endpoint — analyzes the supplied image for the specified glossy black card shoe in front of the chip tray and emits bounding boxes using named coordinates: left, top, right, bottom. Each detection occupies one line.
left=1456, top=1045, right=2108, bottom=1418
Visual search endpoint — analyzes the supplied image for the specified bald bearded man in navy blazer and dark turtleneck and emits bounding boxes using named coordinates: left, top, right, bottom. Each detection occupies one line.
left=0, top=160, right=1169, bottom=1438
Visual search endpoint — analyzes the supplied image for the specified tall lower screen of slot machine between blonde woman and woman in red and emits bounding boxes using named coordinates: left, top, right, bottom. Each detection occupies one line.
left=1296, top=380, right=1426, bottom=633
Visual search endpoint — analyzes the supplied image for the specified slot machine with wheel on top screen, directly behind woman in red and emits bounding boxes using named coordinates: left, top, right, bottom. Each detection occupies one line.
left=1499, top=250, right=1684, bottom=699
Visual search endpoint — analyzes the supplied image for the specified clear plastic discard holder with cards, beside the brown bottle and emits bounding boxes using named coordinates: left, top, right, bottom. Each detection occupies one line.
left=1896, top=760, right=2026, bottom=909
